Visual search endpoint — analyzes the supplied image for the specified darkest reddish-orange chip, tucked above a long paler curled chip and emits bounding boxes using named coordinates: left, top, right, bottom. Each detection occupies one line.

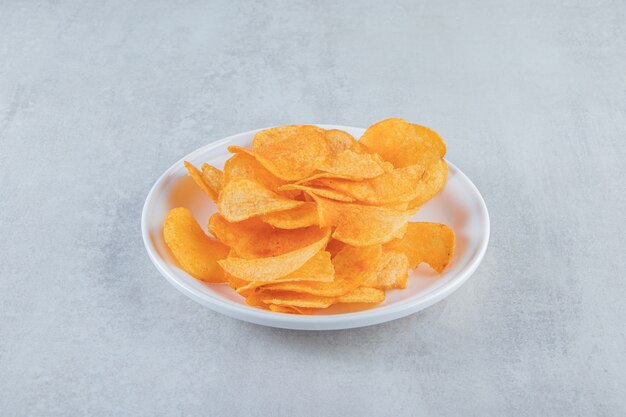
left=209, top=213, right=326, bottom=258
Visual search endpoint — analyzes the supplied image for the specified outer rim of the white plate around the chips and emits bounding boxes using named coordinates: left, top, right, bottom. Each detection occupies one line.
left=141, top=123, right=491, bottom=330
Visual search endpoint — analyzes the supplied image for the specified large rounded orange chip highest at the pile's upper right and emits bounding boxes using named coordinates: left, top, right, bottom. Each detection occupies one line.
left=359, top=118, right=446, bottom=168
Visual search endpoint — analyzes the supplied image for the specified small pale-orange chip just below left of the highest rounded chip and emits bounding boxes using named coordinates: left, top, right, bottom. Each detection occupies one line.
left=318, top=149, right=385, bottom=180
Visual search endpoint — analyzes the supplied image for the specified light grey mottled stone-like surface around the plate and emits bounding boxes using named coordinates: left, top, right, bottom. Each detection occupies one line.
left=0, top=0, right=626, bottom=416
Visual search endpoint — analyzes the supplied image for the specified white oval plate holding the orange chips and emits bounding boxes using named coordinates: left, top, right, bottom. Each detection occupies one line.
left=141, top=125, right=489, bottom=330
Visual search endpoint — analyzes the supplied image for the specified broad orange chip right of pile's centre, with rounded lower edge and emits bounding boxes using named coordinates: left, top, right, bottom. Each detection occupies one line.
left=314, top=196, right=415, bottom=246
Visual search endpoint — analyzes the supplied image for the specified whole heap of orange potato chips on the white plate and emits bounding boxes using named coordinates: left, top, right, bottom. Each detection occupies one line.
left=163, top=119, right=454, bottom=314
